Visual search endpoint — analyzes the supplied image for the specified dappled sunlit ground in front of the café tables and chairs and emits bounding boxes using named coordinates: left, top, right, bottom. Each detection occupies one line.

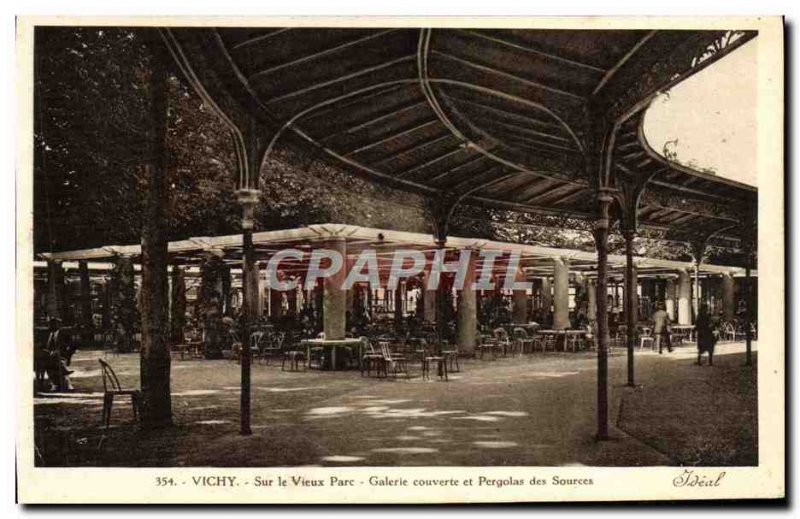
left=35, top=343, right=757, bottom=466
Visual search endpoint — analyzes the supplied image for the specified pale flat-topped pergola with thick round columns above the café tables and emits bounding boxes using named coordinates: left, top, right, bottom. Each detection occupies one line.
left=39, top=223, right=757, bottom=330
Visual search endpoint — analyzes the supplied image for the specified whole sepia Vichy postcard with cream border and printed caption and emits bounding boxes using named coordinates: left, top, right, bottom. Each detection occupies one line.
left=16, top=17, right=786, bottom=504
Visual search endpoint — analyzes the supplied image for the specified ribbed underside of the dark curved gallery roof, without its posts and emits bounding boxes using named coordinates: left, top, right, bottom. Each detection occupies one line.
left=167, top=28, right=754, bottom=246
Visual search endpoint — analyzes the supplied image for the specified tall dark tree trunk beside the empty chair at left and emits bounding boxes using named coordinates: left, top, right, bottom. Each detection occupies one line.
left=140, top=36, right=172, bottom=429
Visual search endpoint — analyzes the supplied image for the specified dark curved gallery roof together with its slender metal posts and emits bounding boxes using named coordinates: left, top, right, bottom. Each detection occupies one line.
left=50, top=27, right=757, bottom=439
